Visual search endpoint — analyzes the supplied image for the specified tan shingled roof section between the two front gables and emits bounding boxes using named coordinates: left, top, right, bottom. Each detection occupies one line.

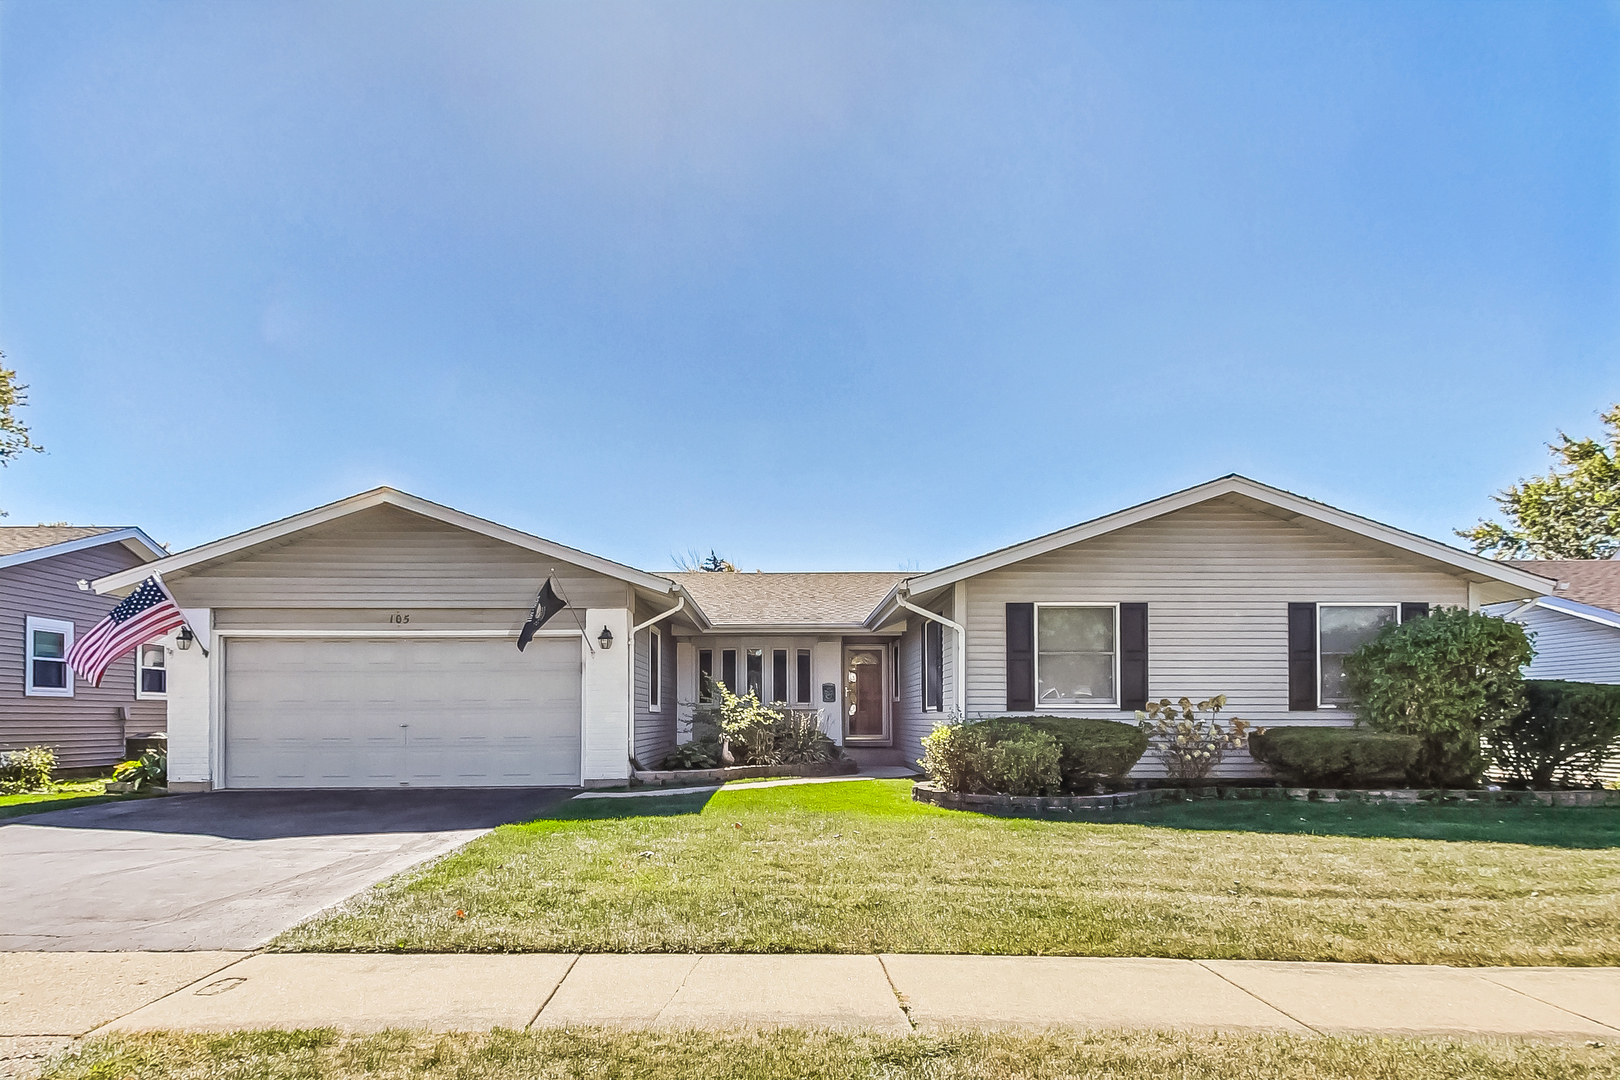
left=669, top=570, right=906, bottom=628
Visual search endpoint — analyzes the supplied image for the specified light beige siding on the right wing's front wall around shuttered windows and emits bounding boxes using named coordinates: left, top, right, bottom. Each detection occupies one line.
left=964, top=500, right=1468, bottom=776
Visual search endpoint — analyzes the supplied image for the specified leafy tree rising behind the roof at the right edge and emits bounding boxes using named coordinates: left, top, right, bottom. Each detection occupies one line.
left=1456, top=403, right=1620, bottom=559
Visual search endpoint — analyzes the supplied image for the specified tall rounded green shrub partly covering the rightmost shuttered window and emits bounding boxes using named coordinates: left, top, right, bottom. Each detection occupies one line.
left=1345, top=607, right=1534, bottom=787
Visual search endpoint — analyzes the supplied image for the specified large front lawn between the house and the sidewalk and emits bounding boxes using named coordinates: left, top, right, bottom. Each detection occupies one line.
left=272, top=780, right=1620, bottom=965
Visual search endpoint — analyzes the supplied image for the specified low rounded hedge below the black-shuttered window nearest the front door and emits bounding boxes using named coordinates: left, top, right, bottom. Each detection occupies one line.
left=920, top=716, right=1147, bottom=795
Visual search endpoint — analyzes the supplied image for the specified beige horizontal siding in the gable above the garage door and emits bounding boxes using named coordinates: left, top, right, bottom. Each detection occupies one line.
left=165, top=507, right=627, bottom=612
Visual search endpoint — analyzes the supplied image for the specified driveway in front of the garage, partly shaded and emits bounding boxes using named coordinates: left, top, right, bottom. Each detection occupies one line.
left=0, top=789, right=573, bottom=952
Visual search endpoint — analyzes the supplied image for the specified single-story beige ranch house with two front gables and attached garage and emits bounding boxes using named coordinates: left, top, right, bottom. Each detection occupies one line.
left=94, top=476, right=1554, bottom=790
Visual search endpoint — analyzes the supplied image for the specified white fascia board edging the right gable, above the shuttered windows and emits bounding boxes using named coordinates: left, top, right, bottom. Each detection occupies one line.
left=902, top=474, right=1555, bottom=596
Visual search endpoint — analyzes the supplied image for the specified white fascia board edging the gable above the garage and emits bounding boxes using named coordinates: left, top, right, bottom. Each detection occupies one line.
left=91, top=487, right=676, bottom=596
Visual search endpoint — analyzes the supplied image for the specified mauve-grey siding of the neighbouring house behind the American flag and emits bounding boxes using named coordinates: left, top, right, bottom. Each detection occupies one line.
left=0, top=544, right=167, bottom=769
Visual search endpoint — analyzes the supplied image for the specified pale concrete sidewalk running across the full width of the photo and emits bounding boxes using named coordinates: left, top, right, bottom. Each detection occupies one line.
left=0, top=952, right=1620, bottom=1041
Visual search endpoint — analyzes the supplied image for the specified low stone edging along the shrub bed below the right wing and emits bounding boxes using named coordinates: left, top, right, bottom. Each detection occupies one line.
left=912, top=780, right=1620, bottom=814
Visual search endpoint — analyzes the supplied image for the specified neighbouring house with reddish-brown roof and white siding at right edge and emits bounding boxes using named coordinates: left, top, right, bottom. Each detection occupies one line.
left=1489, top=559, right=1620, bottom=683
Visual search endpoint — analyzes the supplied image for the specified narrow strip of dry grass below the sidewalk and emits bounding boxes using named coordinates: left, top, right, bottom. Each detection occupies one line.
left=45, top=1030, right=1620, bottom=1080
